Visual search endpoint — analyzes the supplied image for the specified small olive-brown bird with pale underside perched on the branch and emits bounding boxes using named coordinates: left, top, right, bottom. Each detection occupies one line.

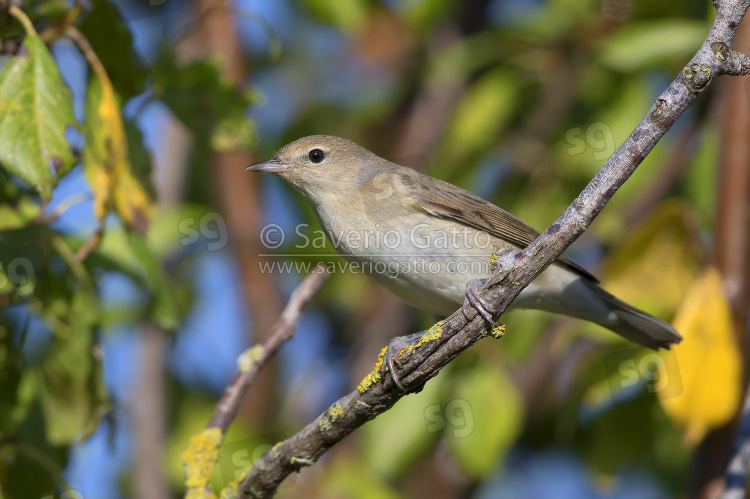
left=247, top=135, right=682, bottom=389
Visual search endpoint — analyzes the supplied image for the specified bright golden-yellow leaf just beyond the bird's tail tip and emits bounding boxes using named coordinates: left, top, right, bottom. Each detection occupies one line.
left=657, top=267, right=742, bottom=443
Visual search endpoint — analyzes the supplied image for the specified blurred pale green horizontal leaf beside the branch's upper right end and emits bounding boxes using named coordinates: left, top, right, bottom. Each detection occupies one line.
left=599, top=19, right=708, bottom=72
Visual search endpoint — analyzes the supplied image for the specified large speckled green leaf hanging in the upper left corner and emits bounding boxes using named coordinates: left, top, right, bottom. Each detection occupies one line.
left=0, top=8, right=77, bottom=199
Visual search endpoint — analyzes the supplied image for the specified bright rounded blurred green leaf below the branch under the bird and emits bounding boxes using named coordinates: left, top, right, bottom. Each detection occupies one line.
left=443, top=365, right=524, bottom=478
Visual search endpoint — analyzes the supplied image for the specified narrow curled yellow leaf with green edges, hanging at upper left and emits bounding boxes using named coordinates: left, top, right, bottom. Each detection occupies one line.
left=84, top=61, right=153, bottom=233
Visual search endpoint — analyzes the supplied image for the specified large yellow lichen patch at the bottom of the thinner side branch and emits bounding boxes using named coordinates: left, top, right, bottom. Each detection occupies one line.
left=182, top=428, right=224, bottom=499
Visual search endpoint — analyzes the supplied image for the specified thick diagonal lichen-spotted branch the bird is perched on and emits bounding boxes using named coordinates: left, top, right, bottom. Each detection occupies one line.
left=223, top=0, right=750, bottom=498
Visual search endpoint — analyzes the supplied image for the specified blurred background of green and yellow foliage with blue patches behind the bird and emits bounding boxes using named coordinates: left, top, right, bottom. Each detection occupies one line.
left=0, top=0, right=750, bottom=499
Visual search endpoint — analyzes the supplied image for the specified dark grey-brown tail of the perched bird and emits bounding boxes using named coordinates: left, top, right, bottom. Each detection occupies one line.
left=586, top=282, right=682, bottom=350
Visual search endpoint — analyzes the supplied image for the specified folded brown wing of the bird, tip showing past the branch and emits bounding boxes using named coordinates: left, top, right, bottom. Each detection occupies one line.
left=412, top=175, right=599, bottom=283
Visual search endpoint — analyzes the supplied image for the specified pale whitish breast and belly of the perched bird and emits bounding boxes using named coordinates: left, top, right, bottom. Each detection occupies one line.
left=318, top=209, right=503, bottom=316
